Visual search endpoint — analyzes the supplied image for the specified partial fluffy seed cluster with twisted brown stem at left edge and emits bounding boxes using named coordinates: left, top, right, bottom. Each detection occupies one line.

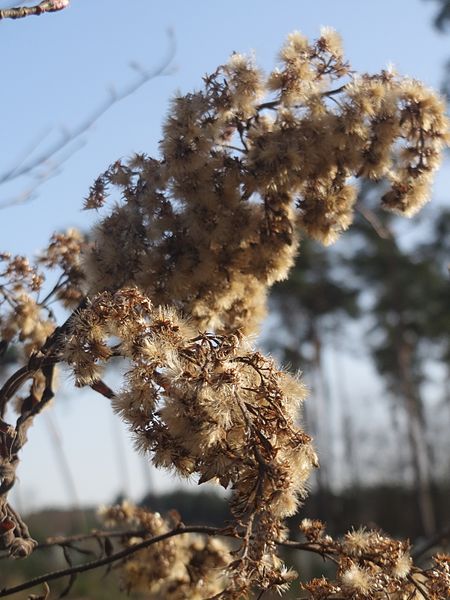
left=0, top=230, right=84, bottom=558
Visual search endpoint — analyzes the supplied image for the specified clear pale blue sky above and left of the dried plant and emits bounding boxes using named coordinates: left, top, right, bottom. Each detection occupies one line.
left=0, top=0, right=450, bottom=508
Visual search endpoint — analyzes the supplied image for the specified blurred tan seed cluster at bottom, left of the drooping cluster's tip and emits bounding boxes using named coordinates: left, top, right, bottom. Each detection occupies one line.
left=99, top=502, right=231, bottom=600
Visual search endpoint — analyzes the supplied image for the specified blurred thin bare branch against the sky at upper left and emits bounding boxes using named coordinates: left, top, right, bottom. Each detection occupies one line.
left=0, top=30, right=176, bottom=209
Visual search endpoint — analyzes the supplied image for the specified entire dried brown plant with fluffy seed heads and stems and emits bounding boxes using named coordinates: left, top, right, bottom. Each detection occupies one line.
left=0, top=29, right=450, bottom=600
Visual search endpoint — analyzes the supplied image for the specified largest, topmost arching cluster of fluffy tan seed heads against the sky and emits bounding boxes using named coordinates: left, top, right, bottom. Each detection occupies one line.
left=85, top=29, right=448, bottom=333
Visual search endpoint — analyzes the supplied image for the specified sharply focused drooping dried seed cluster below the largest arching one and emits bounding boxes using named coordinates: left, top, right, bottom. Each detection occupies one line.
left=65, top=289, right=317, bottom=592
